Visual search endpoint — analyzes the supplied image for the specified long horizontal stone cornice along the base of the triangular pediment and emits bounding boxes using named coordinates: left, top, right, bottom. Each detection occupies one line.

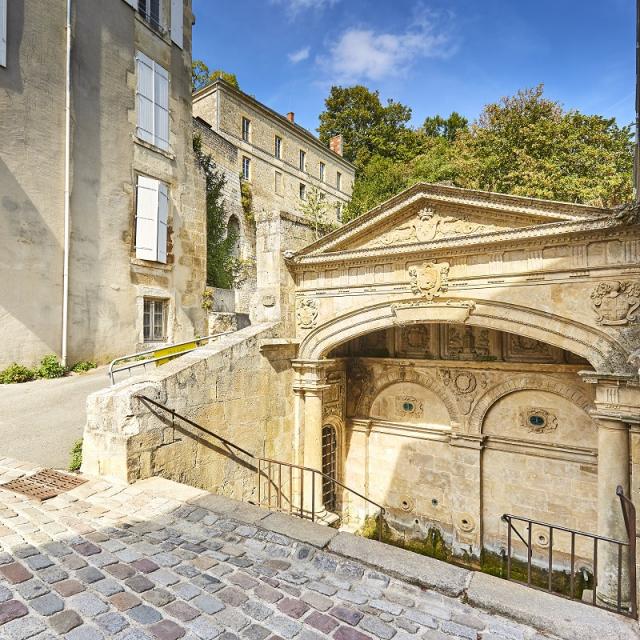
left=289, top=212, right=620, bottom=269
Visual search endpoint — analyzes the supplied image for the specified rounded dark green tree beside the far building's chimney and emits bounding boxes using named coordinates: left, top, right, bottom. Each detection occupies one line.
left=318, top=85, right=418, bottom=169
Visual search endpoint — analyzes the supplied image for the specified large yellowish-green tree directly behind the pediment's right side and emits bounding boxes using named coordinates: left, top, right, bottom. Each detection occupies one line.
left=454, top=85, right=633, bottom=206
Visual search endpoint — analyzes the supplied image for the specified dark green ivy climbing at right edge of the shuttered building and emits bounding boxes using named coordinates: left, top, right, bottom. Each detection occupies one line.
left=193, top=136, right=237, bottom=289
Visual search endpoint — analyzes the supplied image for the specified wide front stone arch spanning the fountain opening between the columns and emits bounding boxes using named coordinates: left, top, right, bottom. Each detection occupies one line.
left=299, top=299, right=632, bottom=373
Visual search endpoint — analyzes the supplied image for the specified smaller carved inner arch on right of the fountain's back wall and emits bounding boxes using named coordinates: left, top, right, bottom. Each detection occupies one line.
left=468, top=373, right=594, bottom=435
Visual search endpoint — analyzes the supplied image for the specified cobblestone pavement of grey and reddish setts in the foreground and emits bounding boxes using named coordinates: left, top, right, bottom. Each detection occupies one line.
left=0, top=459, right=552, bottom=640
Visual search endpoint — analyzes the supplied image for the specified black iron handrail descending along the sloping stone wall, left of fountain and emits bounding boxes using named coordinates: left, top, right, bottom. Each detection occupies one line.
left=135, top=395, right=385, bottom=540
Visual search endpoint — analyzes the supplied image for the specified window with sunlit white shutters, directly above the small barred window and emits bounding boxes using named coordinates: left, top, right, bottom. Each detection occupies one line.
left=136, top=176, right=169, bottom=264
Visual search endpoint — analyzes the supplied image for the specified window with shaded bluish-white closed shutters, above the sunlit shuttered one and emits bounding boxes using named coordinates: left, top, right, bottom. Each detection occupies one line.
left=136, top=51, right=169, bottom=149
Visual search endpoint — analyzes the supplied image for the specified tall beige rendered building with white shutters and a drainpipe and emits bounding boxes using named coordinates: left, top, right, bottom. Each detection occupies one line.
left=0, top=0, right=205, bottom=368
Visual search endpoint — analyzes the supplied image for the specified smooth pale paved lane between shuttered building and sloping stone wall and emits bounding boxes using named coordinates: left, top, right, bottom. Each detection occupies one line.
left=0, top=367, right=109, bottom=469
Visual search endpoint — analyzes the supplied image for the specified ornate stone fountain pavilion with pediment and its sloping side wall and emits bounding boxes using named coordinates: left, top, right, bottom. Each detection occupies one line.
left=85, top=184, right=640, bottom=602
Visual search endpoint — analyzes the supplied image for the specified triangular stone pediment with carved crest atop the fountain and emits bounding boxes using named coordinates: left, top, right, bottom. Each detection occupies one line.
left=298, top=184, right=610, bottom=255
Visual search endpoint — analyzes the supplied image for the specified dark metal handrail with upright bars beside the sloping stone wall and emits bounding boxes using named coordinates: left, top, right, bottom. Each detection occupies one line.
left=135, top=394, right=386, bottom=540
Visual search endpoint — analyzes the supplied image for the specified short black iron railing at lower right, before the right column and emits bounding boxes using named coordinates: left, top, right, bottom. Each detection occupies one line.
left=502, top=486, right=638, bottom=618
